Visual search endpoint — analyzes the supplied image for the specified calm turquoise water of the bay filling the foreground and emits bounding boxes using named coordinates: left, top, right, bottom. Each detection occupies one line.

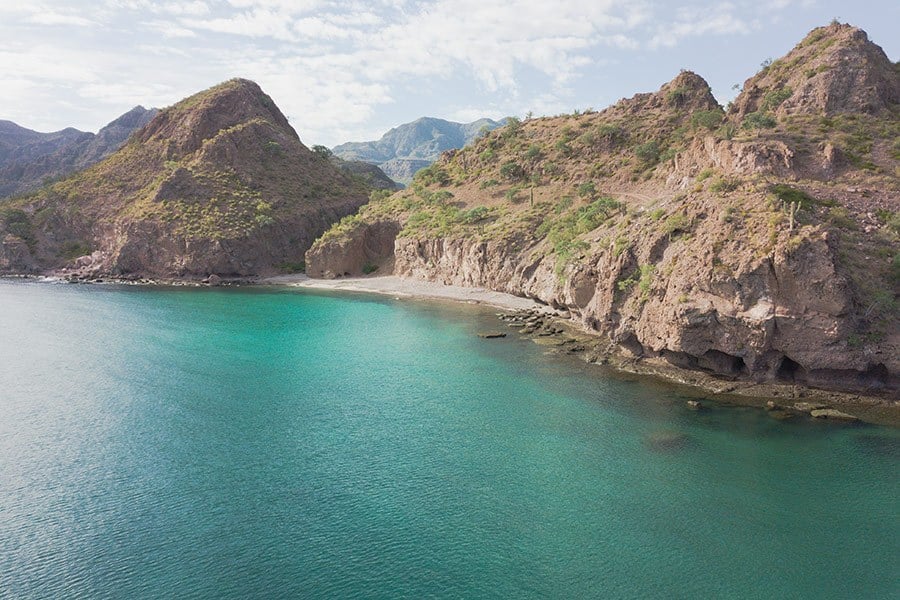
left=0, top=281, right=900, bottom=598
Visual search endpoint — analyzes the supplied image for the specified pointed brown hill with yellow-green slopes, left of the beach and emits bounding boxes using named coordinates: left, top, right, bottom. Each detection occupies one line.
left=0, top=79, right=369, bottom=278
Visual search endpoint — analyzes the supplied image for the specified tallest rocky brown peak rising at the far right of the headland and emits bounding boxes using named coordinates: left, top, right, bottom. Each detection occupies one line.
left=731, top=23, right=900, bottom=117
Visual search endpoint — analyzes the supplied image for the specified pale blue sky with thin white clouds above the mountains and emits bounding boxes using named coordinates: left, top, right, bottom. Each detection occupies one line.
left=0, top=0, right=900, bottom=146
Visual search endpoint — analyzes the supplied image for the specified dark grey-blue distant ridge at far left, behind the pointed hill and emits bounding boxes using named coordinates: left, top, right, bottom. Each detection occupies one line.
left=0, top=106, right=157, bottom=198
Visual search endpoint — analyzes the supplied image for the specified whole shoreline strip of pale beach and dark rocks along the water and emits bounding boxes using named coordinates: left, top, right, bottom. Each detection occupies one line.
left=3, top=273, right=900, bottom=427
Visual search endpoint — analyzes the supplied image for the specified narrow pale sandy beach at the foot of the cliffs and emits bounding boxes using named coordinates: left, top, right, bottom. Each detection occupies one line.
left=260, top=274, right=554, bottom=314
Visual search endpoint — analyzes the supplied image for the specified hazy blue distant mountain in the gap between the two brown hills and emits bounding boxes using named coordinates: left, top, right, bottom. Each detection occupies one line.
left=333, top=117, right=504, bottom=183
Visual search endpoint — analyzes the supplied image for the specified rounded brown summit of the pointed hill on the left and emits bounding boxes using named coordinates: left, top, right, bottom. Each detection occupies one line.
left=138, top=78, right=299, bottom=156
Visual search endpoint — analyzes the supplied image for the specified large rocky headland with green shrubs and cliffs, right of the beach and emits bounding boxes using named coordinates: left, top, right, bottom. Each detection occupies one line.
left=306, top=24, right=900, bottom=404
